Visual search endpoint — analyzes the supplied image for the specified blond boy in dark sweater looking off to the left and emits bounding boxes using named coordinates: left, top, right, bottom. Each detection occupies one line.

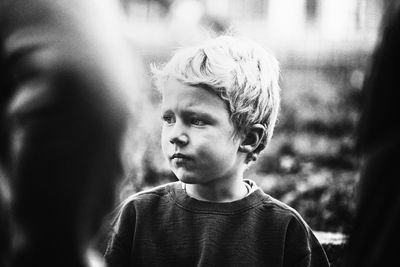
left=106, top=36, right=329, bottom=267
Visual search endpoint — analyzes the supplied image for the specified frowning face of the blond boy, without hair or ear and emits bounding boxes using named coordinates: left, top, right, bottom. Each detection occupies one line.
left=161, top=78, right=245, bottom=184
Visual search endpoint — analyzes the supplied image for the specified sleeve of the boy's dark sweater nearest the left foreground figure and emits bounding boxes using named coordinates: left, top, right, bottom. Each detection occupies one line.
left=105, top=202, right=136, bottom=267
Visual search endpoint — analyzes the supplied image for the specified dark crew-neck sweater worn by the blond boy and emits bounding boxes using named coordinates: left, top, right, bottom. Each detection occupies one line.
left=105, top=181, right=329, bottom=267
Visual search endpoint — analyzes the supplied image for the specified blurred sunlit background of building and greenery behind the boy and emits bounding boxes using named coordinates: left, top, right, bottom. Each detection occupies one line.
left=121, top=0, right=388, bottom=233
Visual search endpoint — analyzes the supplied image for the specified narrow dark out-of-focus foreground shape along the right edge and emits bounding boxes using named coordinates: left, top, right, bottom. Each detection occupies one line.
left=346, top=1, right=400, bottom=267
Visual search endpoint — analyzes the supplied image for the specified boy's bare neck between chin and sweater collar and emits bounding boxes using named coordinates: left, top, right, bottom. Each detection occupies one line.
left=184, top=178, right=249, bottom=202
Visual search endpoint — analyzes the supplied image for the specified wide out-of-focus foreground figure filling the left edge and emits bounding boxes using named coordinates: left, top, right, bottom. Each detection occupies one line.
left=0, top=0, right=144, bottom=267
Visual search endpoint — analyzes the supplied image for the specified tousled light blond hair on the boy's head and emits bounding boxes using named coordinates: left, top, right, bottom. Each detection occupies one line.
left=152, top=36, right=280, bottom=162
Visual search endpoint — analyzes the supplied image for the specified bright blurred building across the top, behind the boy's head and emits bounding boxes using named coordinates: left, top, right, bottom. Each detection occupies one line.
left=125, top=0, right=388, bottom=64
